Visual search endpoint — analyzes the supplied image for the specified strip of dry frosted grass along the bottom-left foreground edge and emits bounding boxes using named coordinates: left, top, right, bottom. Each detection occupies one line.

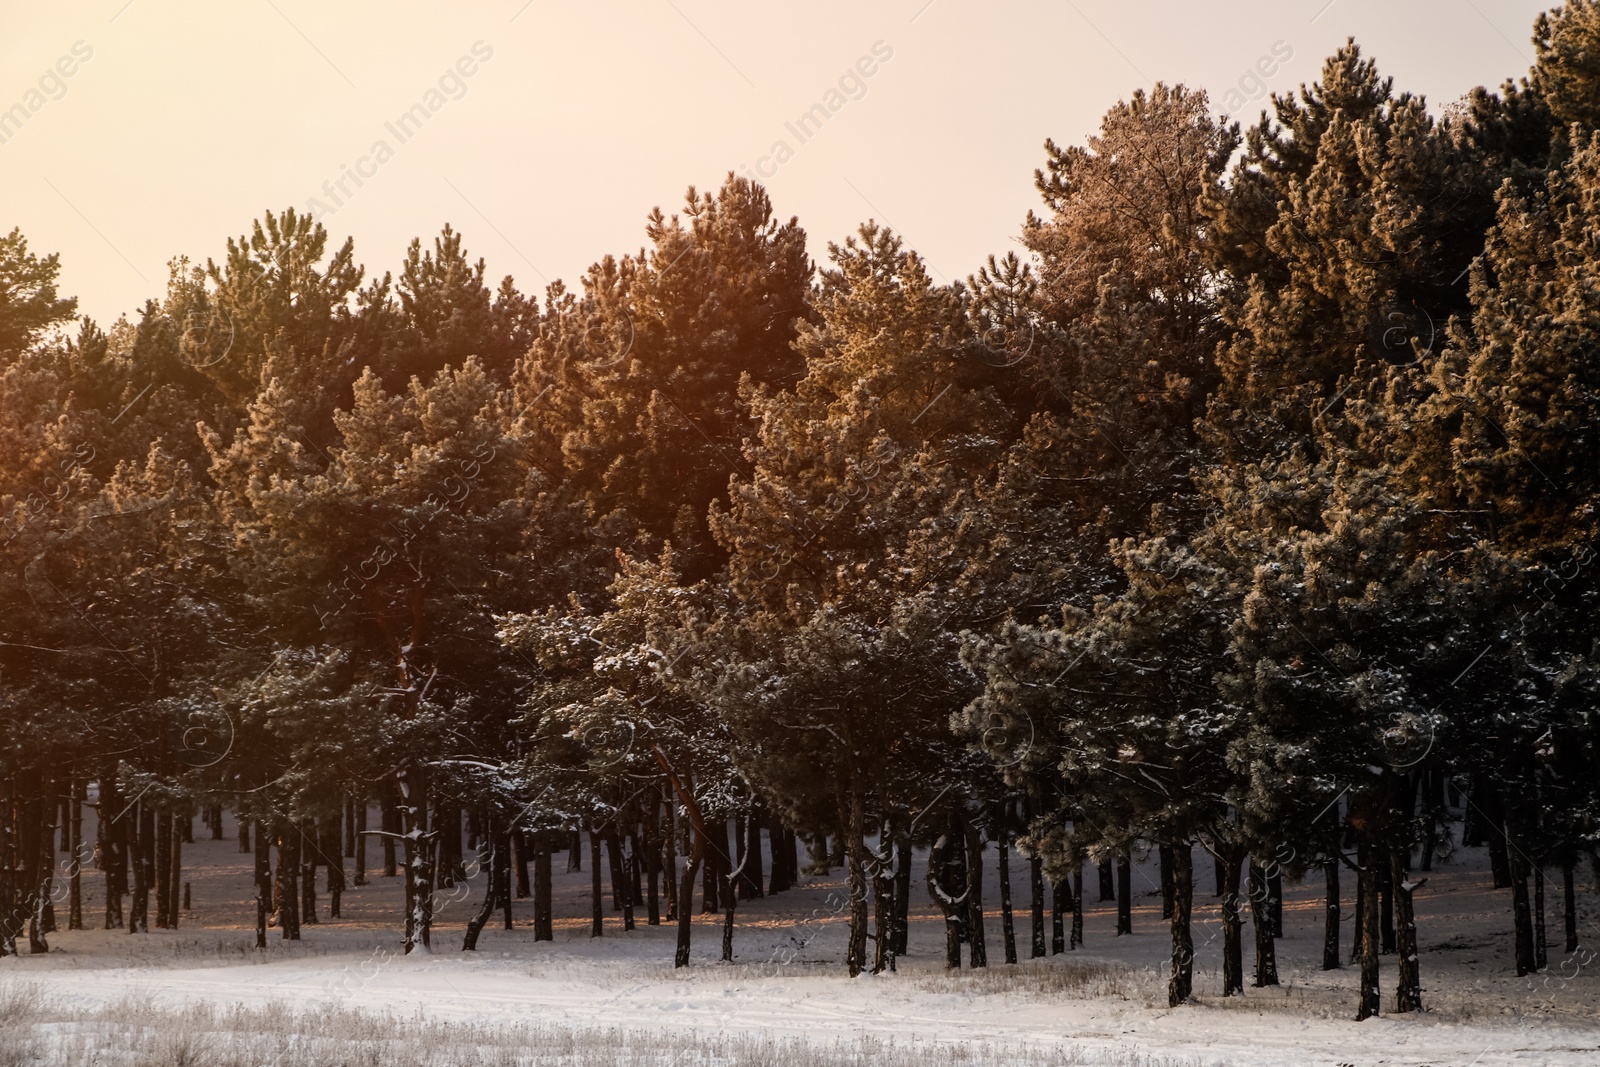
left=0, top=982, right=1209, bottom=1067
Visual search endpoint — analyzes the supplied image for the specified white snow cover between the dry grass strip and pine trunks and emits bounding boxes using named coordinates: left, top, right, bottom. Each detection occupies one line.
left=0, top=809, right=1600, bottom=1067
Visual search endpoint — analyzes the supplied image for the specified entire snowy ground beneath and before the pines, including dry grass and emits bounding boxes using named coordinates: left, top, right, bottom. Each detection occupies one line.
left=0, top=812, right=1600, bottom=1067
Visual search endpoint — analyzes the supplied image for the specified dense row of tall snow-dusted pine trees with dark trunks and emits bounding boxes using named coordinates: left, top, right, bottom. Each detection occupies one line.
left=0, top=0, right=1600, bottom=1017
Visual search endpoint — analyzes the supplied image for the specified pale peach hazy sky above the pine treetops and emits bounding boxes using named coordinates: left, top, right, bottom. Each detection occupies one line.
left=0, top=0, right=1550, bottom=326
